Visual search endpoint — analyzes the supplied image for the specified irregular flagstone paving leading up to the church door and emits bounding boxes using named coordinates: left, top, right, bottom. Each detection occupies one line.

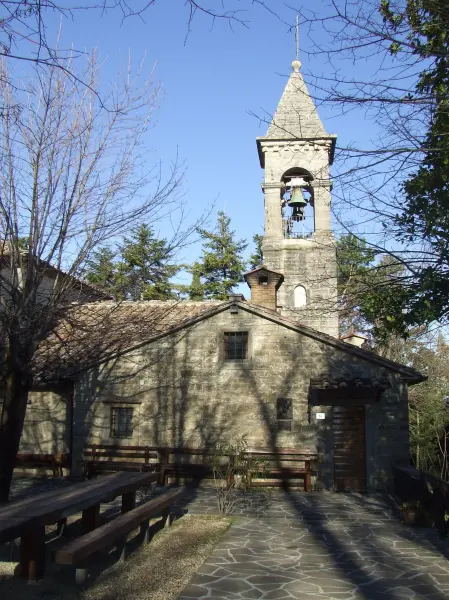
left=173, top=490, right=449, bottom=600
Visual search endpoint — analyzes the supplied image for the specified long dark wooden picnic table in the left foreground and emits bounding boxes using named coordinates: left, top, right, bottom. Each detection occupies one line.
left=0, top=472, right=158, bottom=580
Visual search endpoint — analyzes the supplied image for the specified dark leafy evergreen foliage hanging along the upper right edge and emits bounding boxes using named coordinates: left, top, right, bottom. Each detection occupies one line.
left=393, top=0, right=449, bottom=326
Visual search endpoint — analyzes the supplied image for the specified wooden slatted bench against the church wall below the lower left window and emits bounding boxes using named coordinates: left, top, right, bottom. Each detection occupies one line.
left=83, top=444, right=159, bottom=479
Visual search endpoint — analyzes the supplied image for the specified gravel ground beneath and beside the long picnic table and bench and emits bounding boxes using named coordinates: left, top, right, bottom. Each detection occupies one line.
left=0, top=516, right=232, bottom=600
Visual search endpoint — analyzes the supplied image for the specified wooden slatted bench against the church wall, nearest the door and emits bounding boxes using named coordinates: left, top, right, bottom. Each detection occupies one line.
left=245, top=448, right=318, bottom=492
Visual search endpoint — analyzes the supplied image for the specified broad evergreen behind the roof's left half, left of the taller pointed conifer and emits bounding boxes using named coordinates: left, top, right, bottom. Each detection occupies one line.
left=119, top=224, right=179, bottom=300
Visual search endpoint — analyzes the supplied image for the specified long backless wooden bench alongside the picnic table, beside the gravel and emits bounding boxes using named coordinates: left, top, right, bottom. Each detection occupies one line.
left=55, top=488, right=184, bottom=583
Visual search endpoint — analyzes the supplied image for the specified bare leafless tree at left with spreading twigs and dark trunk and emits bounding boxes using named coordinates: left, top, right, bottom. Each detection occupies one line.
left=0, top=54, right=198, bottom=501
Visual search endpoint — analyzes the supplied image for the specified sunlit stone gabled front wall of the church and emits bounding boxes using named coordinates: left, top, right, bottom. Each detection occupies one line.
left=73, top=302, right=409, bottom=488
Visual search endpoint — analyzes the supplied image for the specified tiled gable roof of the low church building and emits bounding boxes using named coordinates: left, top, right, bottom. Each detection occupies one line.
left=34, top=300, right=427, bottom=383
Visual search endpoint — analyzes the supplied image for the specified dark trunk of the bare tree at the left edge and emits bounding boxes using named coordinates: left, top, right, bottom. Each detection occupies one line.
left=0, top=367, right=29, bottom=503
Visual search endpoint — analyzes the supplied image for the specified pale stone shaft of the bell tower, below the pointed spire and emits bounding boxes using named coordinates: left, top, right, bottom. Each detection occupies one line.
left=259, top=137, right=339, bottom=337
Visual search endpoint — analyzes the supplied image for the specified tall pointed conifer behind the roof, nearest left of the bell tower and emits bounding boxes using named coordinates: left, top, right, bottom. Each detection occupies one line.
left=195, top=211, right=248, bottom=300
